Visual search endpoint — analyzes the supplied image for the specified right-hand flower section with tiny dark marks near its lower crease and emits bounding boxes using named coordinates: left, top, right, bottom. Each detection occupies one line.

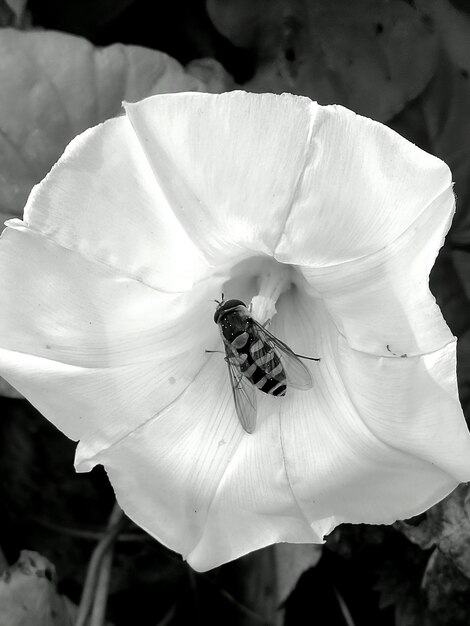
left=301, top=189, right=454, bottom=357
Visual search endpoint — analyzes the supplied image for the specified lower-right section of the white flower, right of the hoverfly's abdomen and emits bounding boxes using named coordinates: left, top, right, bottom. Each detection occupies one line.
left=278, top=288, right=470, bottom=528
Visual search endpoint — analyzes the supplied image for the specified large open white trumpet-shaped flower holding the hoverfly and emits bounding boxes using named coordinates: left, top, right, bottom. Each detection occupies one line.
left=0, top=92, right=470, bottom=570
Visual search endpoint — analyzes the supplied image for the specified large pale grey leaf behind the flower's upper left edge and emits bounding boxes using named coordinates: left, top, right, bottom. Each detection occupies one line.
left=0, top=29, right=228, bottom=224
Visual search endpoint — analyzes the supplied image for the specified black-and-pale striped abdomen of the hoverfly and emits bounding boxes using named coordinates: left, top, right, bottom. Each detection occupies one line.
left=230, top=327, right=286, bottom=396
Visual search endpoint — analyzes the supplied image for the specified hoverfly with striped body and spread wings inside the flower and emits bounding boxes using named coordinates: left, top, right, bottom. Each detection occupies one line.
left=214, top=294, right=320, bottom=433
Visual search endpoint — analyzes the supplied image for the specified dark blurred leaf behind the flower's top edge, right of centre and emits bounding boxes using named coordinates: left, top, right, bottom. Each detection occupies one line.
left=207, top=0, right=437, bottom=121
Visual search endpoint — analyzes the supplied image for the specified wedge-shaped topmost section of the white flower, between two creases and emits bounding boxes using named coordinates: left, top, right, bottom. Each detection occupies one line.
left=126, top=91, right=316, bottom=262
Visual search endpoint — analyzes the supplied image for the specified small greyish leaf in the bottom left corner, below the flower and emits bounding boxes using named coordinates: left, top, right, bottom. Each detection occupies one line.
left=0, top=550, right=73, bottom=626
